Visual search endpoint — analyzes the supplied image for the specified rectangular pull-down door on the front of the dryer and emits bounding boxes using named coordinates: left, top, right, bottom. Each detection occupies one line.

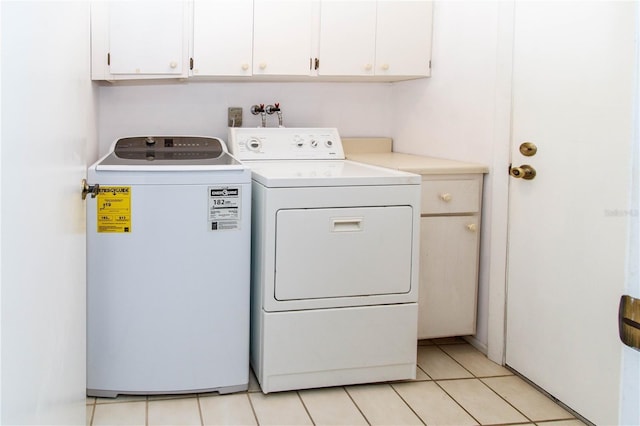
left=275, top=206, right=413, bottom=300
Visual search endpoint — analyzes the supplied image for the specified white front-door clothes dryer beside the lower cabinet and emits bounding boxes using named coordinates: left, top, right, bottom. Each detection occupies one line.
left=228, top=128, right=420, bottom=393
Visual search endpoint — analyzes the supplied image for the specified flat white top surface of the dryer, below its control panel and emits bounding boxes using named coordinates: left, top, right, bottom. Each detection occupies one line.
left=245, top=160, right=421, bottom=188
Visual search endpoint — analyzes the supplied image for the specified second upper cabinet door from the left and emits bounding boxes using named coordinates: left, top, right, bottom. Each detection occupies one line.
left=192, top=0, right=253, bottom=76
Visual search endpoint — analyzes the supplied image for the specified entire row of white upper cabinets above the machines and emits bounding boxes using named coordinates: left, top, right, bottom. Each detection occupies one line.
left=91, top=0, right=432, bottom=81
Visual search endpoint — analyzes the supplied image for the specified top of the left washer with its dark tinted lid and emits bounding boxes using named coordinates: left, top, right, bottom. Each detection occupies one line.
left=96, top=136, right=244, bottom=170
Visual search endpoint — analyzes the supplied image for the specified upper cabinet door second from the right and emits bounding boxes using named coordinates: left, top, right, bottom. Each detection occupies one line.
left=318, top=0, right=376, bottom=76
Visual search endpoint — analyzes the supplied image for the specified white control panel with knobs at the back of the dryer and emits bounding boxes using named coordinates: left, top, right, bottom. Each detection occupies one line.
left=228, top=127, right=344, bottom=160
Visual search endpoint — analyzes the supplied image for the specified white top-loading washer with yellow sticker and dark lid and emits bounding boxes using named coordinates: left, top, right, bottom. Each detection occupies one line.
left=86, top=136, right=251, bottom=397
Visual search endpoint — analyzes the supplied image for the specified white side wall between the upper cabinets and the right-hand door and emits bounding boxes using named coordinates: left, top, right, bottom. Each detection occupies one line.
left=392, top=1, right=510, bottom=352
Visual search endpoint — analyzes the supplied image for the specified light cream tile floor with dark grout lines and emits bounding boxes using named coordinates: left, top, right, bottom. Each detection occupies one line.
left=87, top=338, right=583, bottom=426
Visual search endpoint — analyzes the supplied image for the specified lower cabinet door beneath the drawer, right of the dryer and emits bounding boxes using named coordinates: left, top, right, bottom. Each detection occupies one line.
left=418, top=216, right=480, bottom=339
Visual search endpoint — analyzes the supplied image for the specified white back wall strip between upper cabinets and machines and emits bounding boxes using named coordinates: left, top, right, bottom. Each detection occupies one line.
left=99, top=81, right=392, bottom=154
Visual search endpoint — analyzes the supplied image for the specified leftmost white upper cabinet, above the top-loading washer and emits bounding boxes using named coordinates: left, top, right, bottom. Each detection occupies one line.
left=92, top=0, right=189, bottom=80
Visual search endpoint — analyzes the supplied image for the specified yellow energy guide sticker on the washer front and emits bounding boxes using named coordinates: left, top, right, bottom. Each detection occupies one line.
left=97, top=186, right=131, bottom=232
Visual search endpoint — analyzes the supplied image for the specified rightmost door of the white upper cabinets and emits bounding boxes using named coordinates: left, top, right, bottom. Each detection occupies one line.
left=375, top=1, right=432, bottom=77
